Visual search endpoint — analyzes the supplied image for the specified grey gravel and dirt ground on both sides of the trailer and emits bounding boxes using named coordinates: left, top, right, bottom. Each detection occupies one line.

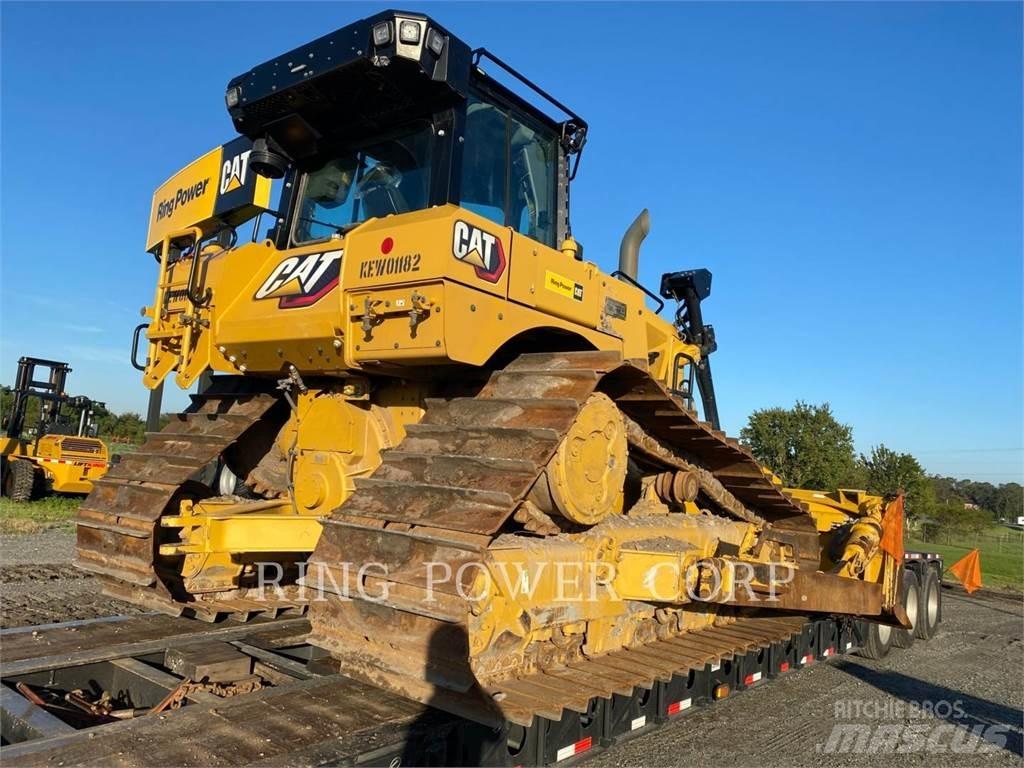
left=0, top=530, right=1024, bottom=768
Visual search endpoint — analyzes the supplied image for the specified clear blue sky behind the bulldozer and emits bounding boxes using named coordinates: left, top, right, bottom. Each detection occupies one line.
left=0, top=2, right=1024, bottom=481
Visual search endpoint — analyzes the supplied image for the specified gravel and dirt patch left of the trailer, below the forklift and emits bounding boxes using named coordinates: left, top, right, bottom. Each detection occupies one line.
left=0, top=530, right=140, bottom=628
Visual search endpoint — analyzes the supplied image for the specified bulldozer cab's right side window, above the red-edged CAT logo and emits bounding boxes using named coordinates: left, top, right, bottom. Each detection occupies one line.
left=460, top=96, right=557, bottom=246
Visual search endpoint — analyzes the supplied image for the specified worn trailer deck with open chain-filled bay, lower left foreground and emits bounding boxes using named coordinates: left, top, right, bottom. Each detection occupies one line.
left=0, top=615, right=453, bottom=766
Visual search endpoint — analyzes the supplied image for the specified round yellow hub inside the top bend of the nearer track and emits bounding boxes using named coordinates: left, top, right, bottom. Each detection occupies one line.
left=529, top=392, right=627, bottom=525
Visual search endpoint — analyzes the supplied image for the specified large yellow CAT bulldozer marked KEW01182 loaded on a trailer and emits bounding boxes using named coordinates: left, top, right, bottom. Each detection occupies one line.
left=77, top=11, right=916, bottom=723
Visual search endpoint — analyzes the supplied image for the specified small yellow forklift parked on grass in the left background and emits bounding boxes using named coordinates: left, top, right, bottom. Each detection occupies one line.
left=0, top=357, right=111, bottom=502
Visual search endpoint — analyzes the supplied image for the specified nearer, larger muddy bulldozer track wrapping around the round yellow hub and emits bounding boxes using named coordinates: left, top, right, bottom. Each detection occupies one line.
left=305, top=352, right=818, bottom=724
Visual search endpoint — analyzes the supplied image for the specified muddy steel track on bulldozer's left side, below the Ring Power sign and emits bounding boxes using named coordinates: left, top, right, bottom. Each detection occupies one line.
left=75, top=377, right=301, bottom=621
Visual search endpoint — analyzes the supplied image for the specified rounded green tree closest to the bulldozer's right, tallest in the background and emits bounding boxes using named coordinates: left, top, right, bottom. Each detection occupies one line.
left=739, top=401, right=863, bottom=489
